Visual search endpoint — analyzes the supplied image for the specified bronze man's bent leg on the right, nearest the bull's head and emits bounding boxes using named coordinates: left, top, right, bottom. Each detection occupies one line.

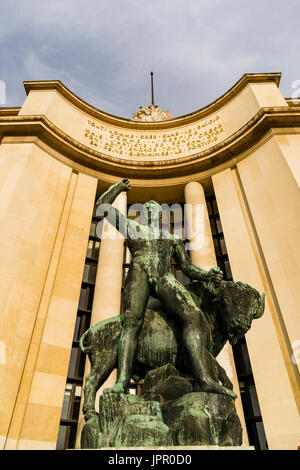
left=156, top=275, right=236, bottom=398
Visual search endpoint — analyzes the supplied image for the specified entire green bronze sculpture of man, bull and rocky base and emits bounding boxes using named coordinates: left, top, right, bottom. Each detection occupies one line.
left=80, top=180, right=264, bottom=448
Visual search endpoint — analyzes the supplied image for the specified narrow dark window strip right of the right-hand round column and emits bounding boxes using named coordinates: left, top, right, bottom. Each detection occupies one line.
left=206, top=196, right=268, bottom=450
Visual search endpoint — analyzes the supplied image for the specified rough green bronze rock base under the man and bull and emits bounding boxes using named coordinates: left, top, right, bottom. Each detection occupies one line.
left=81, top=364, right=242, bottom=449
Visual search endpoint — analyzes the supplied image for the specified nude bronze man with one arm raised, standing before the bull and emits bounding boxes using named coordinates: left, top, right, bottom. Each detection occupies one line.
left=97, top=179, right=236, bottom=398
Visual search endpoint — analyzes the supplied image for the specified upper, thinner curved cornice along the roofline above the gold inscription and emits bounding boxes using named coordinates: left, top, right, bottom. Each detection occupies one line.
left=23, top=73, right=281, bottom=130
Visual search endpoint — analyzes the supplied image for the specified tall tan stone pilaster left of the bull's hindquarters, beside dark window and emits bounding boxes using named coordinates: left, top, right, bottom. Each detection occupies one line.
left=5, top=173, right=97, bottom=450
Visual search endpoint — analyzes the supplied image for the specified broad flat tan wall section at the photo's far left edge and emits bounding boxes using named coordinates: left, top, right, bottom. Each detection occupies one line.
left=0, top=141, right=72, bottom=449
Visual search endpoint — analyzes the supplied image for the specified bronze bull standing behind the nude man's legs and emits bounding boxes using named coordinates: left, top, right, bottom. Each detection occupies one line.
left=80, top=281, right=265, bottom=421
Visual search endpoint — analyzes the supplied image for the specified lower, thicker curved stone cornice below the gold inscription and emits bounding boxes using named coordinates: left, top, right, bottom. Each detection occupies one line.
left=0, top=106, right=300, bottom=179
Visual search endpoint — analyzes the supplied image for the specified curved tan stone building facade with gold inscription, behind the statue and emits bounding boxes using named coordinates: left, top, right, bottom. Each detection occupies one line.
left=0, top=74, right=300, bottom=449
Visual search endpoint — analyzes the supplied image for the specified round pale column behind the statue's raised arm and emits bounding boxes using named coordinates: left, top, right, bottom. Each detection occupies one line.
left=76, top=192, right=127, bottom=448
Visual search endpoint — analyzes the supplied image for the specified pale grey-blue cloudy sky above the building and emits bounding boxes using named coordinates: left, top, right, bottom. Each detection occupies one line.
left=0, top=0, right=300, bottom=118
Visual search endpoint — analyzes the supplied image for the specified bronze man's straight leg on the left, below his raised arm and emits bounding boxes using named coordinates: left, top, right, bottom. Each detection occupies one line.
left=104, top=266, right=150, bottom=393
